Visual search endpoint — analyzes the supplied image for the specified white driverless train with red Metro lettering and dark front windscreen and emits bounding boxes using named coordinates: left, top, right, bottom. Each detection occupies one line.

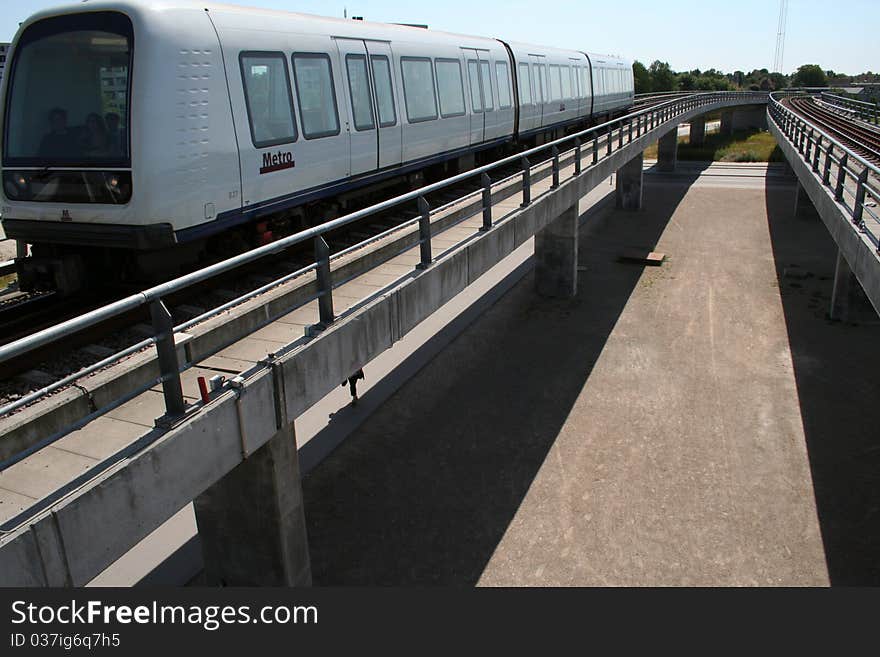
left=0, top=0, right=633, bottom=288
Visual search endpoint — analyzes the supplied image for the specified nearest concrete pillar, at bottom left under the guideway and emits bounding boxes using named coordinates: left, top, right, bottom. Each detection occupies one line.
left=195, top=423, right=312, bottom=586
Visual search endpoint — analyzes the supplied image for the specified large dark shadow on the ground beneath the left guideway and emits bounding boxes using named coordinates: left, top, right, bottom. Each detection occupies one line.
left=303, top=177, right=687, bottom=585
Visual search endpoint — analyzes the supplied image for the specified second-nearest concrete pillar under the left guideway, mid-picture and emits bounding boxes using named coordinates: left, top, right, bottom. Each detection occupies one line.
left=535, top=203, right=578, bottom=298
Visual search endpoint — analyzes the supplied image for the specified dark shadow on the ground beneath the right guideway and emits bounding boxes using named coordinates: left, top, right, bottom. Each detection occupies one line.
left=766, top=169, right=880, bottom=586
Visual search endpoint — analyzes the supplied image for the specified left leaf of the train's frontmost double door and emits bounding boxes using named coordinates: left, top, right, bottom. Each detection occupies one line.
left=335, top=37, right=379, bottom=176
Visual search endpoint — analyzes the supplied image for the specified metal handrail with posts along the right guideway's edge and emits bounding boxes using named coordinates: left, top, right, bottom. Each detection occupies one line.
left=767, top=94, right=880, bottom=247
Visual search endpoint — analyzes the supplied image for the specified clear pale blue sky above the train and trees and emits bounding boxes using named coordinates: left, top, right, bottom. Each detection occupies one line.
left=0, top=0, right=880, bottom=74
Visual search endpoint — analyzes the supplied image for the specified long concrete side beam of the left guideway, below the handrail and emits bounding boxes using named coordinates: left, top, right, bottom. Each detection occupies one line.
left=0, top=95, right=768, bottom=586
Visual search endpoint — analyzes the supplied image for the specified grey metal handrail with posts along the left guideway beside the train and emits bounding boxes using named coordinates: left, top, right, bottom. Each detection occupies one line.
left=0, top=92, right=767, bottom=416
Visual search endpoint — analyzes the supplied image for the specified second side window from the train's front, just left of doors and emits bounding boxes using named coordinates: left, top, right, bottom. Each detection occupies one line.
left=293, top=52, right=339, bottom=139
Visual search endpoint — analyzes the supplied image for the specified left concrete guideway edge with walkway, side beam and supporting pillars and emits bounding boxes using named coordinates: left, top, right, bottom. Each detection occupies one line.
left=0, top=89, right=861, bottom=586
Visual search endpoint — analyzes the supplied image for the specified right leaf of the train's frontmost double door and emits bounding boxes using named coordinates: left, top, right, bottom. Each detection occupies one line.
left=366, top=41, right=403, bottom=169
